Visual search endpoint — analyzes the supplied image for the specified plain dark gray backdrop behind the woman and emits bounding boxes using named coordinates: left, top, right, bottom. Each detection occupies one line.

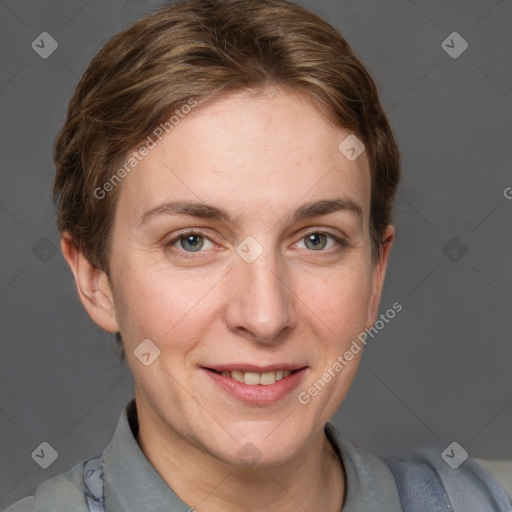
left=0, top=0, right=512, bottom=508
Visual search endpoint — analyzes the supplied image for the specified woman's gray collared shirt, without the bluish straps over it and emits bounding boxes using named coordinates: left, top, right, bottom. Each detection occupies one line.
left=5, top=399, right=402, bottom=512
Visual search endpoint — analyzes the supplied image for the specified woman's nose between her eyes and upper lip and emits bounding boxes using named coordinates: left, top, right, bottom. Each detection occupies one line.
left=226, top=244, right=296, bottom=343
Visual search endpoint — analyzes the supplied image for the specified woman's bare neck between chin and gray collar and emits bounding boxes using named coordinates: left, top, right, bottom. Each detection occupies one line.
left=137, top=402, right=345, bottom=512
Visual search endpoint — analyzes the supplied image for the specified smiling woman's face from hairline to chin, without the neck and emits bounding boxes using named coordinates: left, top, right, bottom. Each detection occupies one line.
left=74, top=90, right=392, bottom=465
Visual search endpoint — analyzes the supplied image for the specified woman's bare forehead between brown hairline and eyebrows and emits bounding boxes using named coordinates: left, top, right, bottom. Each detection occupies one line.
left=114, top=89, right=370, bottom=226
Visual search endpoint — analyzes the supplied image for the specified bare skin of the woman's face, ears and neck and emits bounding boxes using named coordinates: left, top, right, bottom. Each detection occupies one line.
left=62, top=89, right=394, bottom=512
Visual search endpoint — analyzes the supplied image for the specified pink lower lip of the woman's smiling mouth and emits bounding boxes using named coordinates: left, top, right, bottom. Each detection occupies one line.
left=201, top=367, right=307, bottom=405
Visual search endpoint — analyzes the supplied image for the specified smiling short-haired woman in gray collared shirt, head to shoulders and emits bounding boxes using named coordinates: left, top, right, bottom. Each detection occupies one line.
left=9, top=0, right=510, bottom=512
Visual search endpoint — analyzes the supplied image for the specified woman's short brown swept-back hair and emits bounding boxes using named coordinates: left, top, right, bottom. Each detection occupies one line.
left=53, top=0, right=400, bottom=275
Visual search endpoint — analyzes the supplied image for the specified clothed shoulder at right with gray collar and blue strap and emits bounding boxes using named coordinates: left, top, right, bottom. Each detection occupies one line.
left=325, top=423, right=512, bottom=512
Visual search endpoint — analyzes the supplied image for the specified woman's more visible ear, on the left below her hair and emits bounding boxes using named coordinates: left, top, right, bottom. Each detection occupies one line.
left=60, top=232, right=120, bottom=332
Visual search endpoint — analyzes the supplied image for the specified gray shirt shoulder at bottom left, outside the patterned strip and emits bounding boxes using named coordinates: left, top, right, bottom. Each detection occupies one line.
left=5, top=462, right=88, bottom=512
